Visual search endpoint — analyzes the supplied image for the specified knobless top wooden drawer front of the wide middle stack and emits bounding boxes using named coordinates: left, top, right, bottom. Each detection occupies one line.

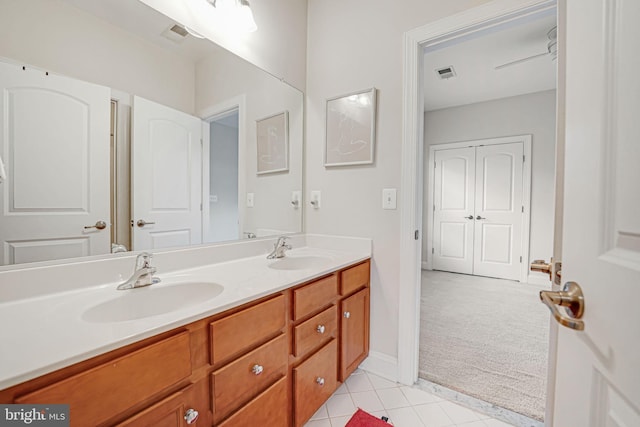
left=209, top=295, right=287, bottom=365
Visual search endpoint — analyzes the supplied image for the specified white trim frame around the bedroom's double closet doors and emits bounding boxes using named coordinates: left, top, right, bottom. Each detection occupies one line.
left=423, top=134, right=532, bottom=282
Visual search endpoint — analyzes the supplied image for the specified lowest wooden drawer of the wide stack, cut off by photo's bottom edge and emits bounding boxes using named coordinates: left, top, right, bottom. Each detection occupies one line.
left=220, top=378, right=289, bottom=427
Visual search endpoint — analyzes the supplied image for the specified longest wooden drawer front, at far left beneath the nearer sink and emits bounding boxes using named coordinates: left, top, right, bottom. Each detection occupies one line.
left=15, top=332, right=191, bottom=426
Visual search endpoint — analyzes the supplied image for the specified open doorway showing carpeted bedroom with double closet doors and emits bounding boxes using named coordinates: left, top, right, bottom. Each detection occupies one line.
left=417, top=3, right=556, bottom=425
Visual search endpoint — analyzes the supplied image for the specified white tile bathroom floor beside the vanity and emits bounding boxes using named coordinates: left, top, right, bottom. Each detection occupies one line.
left=305, top=369, right=511, bottom=427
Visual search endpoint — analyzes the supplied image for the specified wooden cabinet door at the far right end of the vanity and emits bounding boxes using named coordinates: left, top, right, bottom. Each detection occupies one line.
left=340, top=288, right=369, bottom=381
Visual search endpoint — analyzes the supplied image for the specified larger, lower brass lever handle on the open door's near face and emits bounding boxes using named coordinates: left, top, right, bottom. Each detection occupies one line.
left=540, top=282, right=584, bottom=331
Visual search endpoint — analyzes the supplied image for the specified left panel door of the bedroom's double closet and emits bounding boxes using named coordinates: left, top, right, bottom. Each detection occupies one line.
left=432, top=147, right=476, bottom=274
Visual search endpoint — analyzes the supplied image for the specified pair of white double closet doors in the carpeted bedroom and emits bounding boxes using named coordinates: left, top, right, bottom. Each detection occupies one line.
left=432, top=136, right=530, bottom=280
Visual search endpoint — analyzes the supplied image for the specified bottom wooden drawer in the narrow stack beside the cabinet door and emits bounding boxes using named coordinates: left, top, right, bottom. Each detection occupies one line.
left=293, top=339, right=338, bottom=426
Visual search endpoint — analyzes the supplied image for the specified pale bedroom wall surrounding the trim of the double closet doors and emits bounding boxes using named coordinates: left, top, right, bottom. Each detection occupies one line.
left=422, top=90, right=556, bottom=279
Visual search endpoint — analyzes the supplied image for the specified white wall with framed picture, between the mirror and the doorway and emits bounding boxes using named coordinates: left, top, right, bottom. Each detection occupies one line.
left=305, top=0, right=496, bottom=374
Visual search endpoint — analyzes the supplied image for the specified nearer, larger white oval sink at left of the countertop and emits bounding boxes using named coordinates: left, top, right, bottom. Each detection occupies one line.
left=82, top=282, right=224, bottom=323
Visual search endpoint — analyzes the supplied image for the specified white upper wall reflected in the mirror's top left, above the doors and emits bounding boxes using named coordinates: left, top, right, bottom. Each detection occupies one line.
left=0, top=0, right=195, bottom=113
